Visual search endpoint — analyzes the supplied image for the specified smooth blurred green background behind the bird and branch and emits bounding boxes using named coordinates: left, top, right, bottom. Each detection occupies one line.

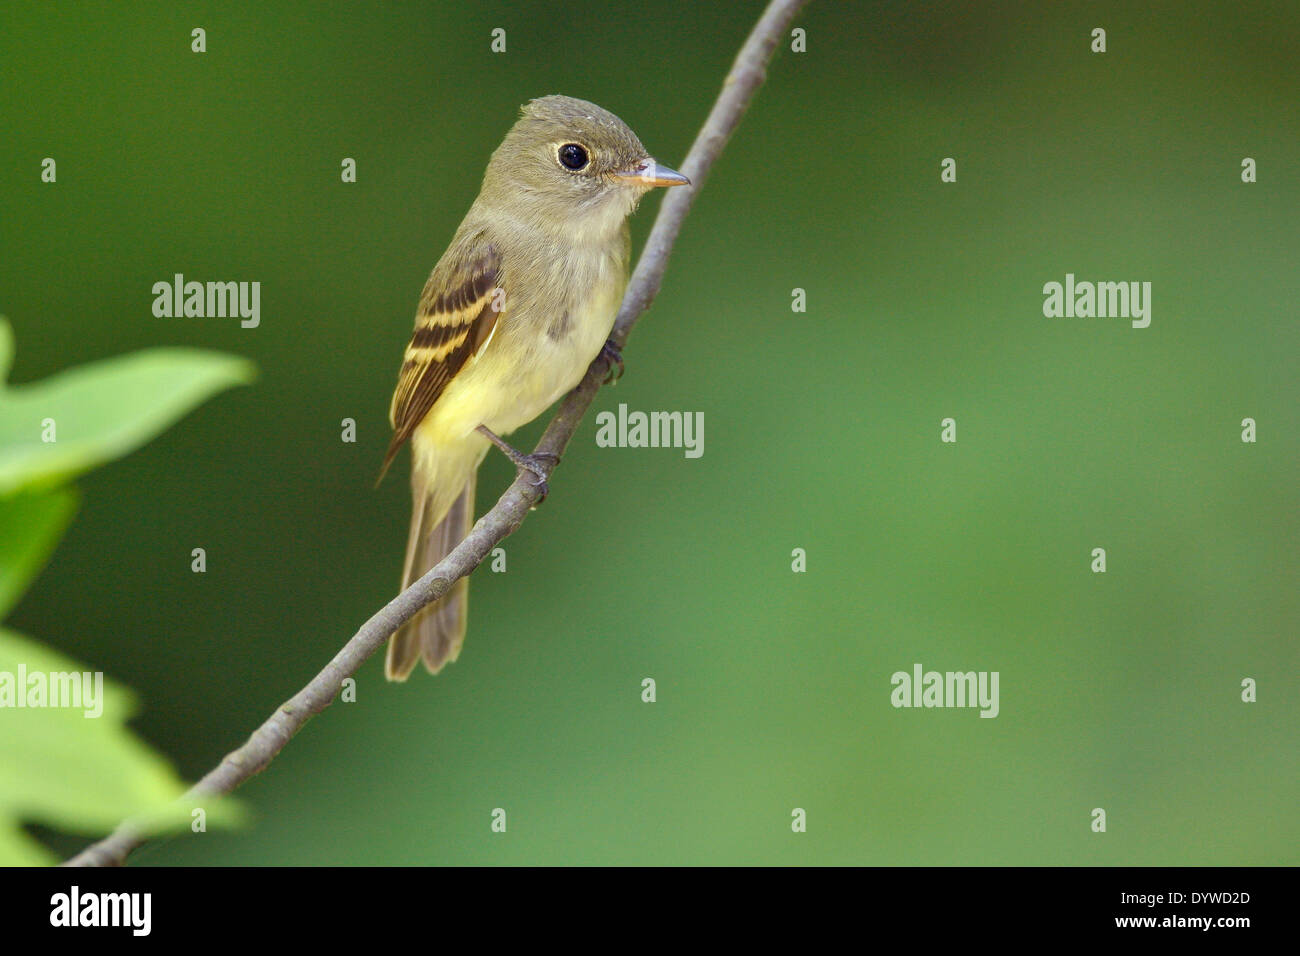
left=0, top=0, right=1300, bottom=865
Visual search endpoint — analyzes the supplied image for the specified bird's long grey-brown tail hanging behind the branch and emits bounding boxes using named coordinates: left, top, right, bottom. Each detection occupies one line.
left=384, top=468, right=477, bottom=680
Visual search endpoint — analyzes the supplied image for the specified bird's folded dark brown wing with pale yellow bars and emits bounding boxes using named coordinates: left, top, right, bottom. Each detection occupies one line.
left=380, top=242, right=504, bottom=479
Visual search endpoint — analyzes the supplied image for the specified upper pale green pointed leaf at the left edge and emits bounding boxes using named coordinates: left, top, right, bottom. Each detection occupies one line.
left=0, top=320, right=254, bottom=494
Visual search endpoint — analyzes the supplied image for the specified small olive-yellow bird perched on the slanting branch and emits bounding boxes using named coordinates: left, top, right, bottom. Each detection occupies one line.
left=380, top=96, right=690, bottom=680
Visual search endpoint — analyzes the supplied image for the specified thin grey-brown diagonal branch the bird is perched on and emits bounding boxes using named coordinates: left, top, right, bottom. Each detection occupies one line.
left=65, top=0, right=809, bottom=866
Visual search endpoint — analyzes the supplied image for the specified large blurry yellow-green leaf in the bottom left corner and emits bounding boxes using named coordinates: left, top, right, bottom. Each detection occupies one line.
left=0, top=628, right=243, bottom=865
